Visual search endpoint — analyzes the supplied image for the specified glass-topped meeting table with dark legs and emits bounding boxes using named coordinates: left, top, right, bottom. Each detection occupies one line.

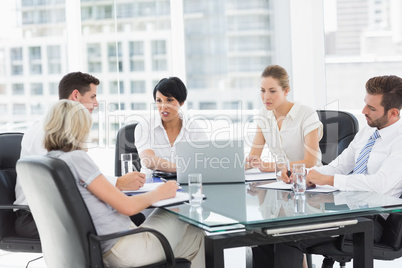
left=164, top=182, right=402, bottom=268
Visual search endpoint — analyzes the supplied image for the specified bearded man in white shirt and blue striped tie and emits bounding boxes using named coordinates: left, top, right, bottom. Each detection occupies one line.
left=253, top=75, right=402, bottom=268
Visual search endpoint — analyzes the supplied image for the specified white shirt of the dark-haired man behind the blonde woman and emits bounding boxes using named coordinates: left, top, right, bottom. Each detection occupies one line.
left=14, top=116, right=117, bottom=206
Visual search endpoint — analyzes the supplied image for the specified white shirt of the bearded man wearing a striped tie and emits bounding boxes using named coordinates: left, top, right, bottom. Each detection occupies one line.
left=316, top=120, right=402, bottom=197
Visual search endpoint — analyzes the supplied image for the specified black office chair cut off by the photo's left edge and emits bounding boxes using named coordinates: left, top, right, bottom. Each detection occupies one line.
left=0, top=133, right=42, bottom=253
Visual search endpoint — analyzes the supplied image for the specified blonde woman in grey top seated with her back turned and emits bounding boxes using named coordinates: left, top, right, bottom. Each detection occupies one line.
left=44, top=100, right=205, bottom=268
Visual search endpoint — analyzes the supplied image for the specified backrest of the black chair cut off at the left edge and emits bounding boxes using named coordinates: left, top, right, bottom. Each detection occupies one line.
left=0, top=132, right=23, bottom=238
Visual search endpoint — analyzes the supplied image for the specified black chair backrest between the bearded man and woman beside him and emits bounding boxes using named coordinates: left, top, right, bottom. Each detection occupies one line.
left=317, top=110, right=359, bottom=165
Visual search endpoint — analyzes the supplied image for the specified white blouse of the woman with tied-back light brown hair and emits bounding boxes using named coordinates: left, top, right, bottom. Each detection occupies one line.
left=256, top=102, right=323, bottom=166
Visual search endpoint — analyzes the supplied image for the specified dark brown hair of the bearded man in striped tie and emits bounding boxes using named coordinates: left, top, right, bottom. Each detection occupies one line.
left=366, top=75, right=402, bottom=112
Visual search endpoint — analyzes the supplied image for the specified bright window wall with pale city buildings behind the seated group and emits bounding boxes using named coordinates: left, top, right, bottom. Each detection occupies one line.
left=0, top=0, right=402, bottom=267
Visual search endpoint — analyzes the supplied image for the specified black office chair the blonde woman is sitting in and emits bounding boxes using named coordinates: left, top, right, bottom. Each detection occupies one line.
left=17, top=156, right=191, bottom=268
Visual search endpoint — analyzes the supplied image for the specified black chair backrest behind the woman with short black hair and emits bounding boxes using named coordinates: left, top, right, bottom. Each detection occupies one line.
left=114, top=123, right=141, bottom=176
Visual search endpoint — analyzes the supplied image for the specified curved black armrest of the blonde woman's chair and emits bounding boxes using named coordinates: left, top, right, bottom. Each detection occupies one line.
left=89, top=227, right=176, bottom=267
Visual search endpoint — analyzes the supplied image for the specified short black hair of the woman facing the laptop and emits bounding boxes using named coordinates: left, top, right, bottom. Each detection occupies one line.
left=154, top=77, right=187, bottom=103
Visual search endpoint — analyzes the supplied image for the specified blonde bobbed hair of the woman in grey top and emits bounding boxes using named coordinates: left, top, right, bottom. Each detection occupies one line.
left=43, top=100, right=92, bottom=152
